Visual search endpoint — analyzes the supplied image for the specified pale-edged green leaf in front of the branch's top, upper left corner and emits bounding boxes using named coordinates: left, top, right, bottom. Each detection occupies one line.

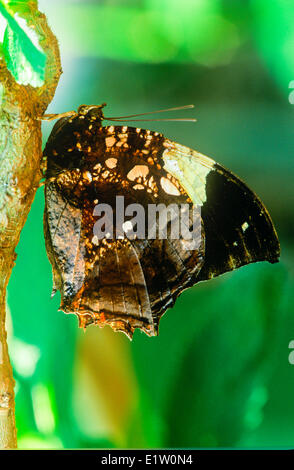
left=0, top=1, right=46, bottom=87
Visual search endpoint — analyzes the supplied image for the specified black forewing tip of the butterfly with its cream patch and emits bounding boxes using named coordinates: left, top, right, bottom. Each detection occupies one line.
left=162, top=140, right=280, bottom=282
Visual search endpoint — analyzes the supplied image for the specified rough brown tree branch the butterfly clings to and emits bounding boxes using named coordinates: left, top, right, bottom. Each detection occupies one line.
left=0, top=2, right=61, bottom=449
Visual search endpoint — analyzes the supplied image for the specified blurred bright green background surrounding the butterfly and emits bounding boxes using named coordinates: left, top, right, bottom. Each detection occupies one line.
left=0, top=0, right=294, bottom=448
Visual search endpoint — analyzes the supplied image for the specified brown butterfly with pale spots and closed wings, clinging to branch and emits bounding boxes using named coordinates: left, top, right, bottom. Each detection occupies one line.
left=44, top=104, right=280, bottom=338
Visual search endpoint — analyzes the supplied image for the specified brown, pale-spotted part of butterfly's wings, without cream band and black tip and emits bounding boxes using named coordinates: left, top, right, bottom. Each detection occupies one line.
left=44, top=120, right=204, bottom=337
